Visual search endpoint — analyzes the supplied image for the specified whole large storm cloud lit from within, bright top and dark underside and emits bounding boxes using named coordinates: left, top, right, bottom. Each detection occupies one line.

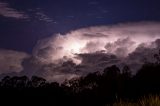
left=0, top=22, right=160, bottom=82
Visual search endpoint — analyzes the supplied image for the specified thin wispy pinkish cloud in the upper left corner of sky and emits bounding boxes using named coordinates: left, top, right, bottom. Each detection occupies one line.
left=0, top=2, right=29, bottom=19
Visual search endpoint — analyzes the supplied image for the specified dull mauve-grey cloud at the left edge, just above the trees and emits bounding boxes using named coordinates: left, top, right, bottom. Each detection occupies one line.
left=0, top=49, right=29, bottom=74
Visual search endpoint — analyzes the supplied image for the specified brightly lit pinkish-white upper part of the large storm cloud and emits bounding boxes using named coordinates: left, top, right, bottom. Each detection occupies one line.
left=34, top=22, right=160, bottom=64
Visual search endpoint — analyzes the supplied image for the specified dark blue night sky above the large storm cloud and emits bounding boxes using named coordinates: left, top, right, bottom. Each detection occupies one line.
left=0, top=0, right=160, bottom=53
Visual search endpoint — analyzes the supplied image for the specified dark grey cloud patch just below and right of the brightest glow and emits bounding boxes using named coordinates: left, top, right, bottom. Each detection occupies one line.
left=75, top=52, right=120, bottom=74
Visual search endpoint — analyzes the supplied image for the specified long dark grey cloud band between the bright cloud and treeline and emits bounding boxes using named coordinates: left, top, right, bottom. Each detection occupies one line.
left=21, top=52, right=119, bottom=82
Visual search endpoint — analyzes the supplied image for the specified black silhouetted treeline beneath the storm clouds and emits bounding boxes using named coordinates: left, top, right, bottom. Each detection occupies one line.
left=0, top=54, right=160, bottom=106
